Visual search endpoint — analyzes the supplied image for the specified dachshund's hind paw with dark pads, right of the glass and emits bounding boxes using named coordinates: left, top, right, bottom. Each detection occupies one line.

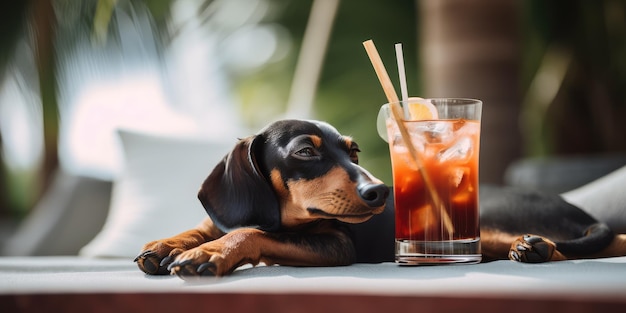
left=509, top=235, right=562, bottom=263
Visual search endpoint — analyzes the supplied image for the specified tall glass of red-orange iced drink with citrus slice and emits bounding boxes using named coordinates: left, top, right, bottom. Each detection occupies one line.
left=381, top=99, right=482, bottom=264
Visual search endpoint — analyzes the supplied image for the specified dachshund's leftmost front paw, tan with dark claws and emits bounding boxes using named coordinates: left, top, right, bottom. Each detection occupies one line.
left=135, top=240, right=184, bottom=275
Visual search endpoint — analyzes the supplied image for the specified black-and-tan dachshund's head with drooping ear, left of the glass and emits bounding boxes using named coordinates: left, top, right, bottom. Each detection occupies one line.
left=198, top=120, right=389, bottom=231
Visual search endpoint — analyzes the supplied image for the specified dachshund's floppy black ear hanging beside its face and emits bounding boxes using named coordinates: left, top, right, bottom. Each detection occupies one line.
left=198, top=136, right=280, bottom=232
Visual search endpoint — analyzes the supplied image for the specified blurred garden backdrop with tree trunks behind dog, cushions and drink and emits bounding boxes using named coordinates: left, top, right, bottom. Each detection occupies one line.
left=0, top=0, right=626, bottom=254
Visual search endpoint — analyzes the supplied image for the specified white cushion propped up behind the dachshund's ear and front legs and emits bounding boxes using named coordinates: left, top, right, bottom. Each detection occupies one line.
left=79, top=130, right=236, bottom=257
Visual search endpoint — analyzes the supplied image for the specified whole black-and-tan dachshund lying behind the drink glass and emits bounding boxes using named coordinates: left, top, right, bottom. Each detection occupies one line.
left=135, top=120, right=626, bottom=278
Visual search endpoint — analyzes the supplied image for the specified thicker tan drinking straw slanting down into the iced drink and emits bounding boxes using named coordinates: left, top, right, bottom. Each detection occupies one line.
left=363, top=39, right=454, bottom=239
